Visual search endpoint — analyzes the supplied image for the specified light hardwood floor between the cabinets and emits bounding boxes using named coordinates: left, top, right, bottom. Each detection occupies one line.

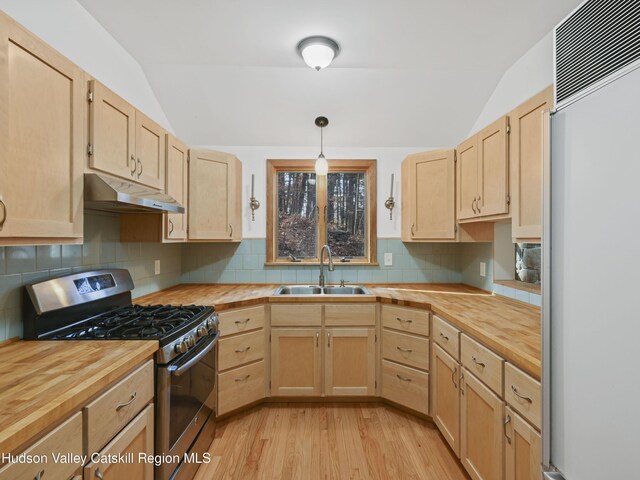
left=195, top=403, right=469, bottom=480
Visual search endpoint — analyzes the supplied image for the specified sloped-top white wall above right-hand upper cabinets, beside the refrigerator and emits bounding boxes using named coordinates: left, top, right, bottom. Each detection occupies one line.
left=469, top=32, right=553, bottom=135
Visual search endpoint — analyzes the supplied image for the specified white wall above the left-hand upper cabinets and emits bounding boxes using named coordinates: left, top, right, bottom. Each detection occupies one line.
left=0, top=0, right=173, bottom=132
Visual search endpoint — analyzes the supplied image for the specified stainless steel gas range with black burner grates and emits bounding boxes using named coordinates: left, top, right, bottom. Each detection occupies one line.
left=24, top=269, right=219, bottom=480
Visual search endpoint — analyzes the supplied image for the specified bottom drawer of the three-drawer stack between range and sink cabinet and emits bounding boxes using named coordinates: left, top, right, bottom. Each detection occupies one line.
left=218, top=360, right=264, bottom=415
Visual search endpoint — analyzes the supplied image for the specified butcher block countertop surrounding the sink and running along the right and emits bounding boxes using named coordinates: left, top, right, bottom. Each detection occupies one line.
left=135, top=284, right=541, bottom=379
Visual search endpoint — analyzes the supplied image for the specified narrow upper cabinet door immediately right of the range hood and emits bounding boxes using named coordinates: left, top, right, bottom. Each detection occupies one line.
left=164, top=134, right=189, bottom=240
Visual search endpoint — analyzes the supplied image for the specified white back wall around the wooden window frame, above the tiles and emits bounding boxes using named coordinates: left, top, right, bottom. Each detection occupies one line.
left=202, top=145, right=434, bottom=238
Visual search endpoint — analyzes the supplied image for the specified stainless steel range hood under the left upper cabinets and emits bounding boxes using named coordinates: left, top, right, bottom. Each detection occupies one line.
left=84, top=173, right=184, bottom=213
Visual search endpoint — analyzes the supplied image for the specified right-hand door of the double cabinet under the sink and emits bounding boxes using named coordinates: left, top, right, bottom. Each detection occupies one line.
left=324, top=328, right=376, bottom=395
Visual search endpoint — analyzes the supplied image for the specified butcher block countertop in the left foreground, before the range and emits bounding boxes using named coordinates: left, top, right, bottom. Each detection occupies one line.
left=0, top=340, right=158, bottom=455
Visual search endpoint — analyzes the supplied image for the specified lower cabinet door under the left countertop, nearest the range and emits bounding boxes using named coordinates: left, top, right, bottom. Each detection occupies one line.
left=83, top=404, right=154, bottom=480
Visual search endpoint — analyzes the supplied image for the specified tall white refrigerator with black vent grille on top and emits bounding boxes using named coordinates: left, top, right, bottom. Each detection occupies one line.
left=542, top=0, right=640, bottom=480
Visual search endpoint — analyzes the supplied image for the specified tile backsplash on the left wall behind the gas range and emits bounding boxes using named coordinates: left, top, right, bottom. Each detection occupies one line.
left=0, top=213, right=182, bottom=340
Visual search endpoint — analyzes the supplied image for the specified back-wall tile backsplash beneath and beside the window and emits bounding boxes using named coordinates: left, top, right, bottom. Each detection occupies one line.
left=182, top=238, right=462, bottom=284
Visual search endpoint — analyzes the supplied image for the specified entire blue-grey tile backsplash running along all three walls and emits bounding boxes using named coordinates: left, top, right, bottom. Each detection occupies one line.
left=0, top=221, right=541, bottom=340
